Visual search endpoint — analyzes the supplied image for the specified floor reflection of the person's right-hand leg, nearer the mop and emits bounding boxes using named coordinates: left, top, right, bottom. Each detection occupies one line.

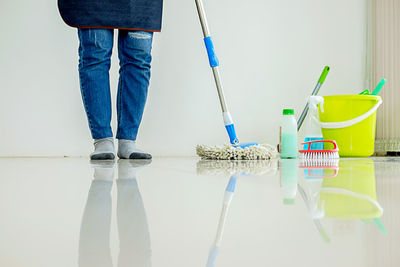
left=117, top=161, right=151, bottom=267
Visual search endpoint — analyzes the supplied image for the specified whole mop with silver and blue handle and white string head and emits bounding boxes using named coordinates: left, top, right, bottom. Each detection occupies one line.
left=196, top=0, right=277, bottom=160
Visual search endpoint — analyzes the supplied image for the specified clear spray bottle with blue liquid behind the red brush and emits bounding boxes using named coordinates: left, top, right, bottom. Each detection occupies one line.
left=304, top=96, right=324, bottom=150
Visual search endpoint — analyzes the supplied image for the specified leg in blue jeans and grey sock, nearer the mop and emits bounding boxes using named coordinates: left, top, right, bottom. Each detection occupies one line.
left=116, top=30, right=153, bottom=159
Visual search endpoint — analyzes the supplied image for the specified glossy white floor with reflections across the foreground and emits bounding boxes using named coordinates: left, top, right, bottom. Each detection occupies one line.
left=0, top=158, right=400, bottom=267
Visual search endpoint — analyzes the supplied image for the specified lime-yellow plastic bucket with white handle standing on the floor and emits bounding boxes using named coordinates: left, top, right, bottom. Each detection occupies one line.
left=319, top=95, right=382, bottom=157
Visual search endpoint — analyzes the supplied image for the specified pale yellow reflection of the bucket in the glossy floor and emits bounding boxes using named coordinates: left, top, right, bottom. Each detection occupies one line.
left=319, top=159, right=383, bottom=219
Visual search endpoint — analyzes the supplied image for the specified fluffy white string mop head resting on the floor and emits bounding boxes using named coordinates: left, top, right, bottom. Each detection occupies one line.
left=196, top=144, right=278, bottom=160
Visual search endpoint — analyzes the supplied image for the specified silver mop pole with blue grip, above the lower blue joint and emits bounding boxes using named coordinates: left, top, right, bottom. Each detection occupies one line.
left=196, top=0, right=228, bottom=113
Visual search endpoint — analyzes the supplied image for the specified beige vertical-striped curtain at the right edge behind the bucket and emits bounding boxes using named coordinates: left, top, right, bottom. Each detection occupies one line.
left=366, top=0, right=400, bottom=153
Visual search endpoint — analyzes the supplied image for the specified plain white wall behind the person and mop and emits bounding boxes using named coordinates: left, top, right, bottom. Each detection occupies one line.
left=0, top=0, right=365, bottom=156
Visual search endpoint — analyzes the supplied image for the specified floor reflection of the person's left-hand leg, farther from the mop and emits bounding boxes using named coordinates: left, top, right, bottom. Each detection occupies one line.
left=79, top=165, right=114, bottom=267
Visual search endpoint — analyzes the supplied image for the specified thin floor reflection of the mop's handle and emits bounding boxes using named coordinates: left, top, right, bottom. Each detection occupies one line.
left=206, top=175, right=237, bottom=267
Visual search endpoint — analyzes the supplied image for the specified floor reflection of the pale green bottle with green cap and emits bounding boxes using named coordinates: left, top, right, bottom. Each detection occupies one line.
left=280, top=159, right=298, bottom=205
